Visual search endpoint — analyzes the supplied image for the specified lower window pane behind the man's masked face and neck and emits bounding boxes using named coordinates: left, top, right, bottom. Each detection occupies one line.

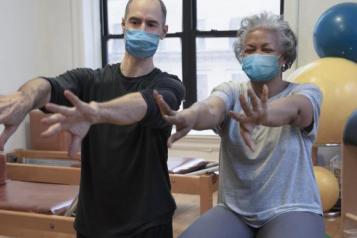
left=108, top=38, right=182, bottom=80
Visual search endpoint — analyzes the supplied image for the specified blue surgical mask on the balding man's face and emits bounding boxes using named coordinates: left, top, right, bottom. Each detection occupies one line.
left=125, top=29, right=160, bottom=58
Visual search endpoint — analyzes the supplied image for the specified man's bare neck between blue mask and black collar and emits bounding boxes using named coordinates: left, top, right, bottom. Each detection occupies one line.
left=120, top=53, right=155, bottom=78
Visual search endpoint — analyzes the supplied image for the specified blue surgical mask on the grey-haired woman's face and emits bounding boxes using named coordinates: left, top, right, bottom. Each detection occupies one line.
left=242, top=54, right=280, bottom=82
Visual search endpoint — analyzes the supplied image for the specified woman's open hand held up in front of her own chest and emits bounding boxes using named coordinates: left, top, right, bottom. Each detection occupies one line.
left=229, top=85, right=269, bottom=151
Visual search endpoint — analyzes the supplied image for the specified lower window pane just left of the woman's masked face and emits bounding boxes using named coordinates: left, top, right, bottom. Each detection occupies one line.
left=196, top=38, right=248, bottom=101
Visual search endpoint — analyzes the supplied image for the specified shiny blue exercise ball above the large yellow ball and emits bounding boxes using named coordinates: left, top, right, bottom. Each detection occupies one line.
left=313, top=2, right=357, bottom=62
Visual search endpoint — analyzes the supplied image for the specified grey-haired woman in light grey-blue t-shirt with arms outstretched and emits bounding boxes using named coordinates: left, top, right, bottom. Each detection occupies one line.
left=155, top=13, right=324, bottom=238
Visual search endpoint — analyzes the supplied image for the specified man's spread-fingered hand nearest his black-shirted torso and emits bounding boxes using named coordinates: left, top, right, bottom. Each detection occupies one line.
left=42, top=90, right=98, bottom=157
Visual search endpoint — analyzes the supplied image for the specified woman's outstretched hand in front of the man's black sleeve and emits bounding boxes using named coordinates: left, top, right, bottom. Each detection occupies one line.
left=154, top=90, right=197, bottom=147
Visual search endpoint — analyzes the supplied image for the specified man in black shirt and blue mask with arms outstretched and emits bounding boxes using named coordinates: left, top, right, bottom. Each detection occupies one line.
left=0, top=0, right=184, bottom=238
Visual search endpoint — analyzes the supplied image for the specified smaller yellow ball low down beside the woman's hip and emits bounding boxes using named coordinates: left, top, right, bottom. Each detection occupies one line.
left=314, top=166, right=340, bottom=212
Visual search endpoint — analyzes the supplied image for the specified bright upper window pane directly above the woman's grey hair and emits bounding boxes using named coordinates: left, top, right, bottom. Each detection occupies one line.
left=197, top=0, right=280, bottom=31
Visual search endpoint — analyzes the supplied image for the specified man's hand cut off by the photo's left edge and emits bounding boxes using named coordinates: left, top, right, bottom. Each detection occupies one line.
left=0, top=92, right=31, bottom=151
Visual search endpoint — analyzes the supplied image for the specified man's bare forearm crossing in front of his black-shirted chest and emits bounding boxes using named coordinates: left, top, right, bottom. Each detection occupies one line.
left=94, top=93, right=147, bottom=125
